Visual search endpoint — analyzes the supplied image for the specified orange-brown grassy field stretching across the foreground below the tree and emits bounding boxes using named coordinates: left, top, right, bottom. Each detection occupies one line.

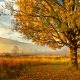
left=0, top=57, right=80, bottom=80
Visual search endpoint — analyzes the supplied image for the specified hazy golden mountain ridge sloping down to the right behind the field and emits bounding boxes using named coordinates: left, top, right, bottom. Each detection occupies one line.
left=0, top=37, right=53, bottom=53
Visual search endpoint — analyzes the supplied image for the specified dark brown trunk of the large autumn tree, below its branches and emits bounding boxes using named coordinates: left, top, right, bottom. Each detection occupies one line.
left=70, top=46, right=78, bottom=69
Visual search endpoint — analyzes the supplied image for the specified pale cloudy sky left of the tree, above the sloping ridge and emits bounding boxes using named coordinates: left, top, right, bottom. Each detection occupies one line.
left=0, top=0, right=31, bottom=43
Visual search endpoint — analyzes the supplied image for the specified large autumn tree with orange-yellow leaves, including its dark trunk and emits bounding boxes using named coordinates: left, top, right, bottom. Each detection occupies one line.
left=15, top=0, right=80, bottom=68
